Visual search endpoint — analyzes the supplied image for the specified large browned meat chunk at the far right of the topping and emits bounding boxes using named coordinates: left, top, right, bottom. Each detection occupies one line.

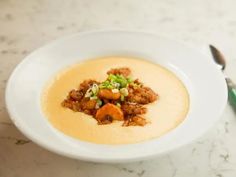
left=126, top=86, right=157, bottom=104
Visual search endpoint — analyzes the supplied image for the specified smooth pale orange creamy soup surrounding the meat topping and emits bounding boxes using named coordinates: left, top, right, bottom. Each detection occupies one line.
left=42, top=57, right=189, bottom=144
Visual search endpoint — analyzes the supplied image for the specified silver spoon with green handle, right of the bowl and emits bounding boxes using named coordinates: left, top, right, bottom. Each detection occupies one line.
left=209, top=45, right=236, bottom=110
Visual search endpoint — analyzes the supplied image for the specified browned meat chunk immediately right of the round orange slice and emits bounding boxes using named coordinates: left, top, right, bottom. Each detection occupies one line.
left=121, top=102, right=147, bottom=118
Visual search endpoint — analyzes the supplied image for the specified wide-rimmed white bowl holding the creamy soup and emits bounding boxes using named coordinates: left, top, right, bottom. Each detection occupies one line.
left=6, top=31, right=227, bottom=163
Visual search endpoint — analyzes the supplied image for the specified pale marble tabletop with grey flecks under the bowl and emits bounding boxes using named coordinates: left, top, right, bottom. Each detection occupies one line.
left=0, top=0, right=236, bottom=177
